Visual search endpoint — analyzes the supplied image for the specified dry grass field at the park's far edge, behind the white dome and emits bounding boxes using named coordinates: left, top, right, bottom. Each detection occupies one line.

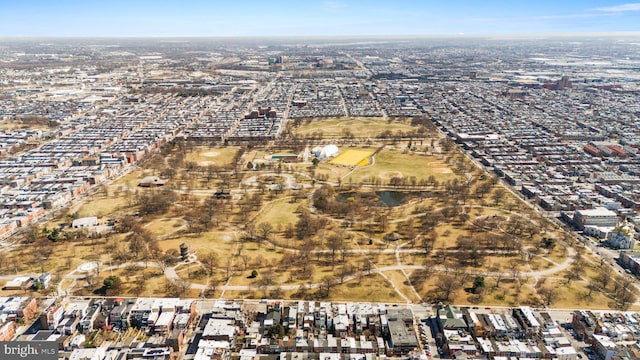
left=293, top=118, right=416, bottom=138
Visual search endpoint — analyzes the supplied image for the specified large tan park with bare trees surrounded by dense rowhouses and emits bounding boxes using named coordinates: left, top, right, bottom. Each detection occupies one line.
left=0, top=119, right=635, bottom=309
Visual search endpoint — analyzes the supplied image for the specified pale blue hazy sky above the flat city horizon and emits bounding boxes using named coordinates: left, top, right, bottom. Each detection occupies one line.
left=0, top=0, right=640, bottom=37
